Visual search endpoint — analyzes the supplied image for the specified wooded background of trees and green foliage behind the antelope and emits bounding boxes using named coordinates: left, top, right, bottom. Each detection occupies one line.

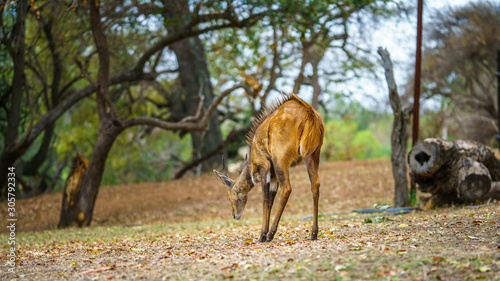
left=0, top=0, right=500, bottom=206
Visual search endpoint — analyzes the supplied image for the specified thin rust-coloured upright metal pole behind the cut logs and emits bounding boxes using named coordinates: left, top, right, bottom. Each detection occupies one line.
left=412, top=0, right=424, bottom=146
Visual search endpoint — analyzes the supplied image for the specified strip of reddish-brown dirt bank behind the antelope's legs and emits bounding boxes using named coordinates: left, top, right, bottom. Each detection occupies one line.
left=0, top=159, right=394, bottom=232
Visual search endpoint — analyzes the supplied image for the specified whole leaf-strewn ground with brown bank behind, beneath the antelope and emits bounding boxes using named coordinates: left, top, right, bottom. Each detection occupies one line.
left=0, top=159, right=500, bottom=280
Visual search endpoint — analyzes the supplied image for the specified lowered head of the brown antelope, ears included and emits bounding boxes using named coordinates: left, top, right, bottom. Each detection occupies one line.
left=214, top=156, right=255, bottom=220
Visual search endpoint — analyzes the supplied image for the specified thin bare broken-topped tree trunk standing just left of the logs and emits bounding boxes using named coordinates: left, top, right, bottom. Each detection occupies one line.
left=378, top=47, right=410, bottom=207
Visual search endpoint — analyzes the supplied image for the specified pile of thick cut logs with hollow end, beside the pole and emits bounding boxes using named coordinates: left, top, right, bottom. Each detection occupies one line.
left=408, top=139, right=500, bottom=209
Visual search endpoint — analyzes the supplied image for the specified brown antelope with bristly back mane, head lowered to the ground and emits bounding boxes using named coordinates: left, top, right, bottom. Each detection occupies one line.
left=214, top=94, right=325, bottom=242
